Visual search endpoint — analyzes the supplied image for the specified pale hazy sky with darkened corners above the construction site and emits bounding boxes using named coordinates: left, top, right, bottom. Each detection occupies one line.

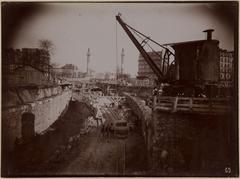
left=6, top=3, right=234, bottom=75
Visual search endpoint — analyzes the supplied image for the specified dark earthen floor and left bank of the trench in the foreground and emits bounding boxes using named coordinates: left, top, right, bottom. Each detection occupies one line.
left=9, top=101, right=146, bottom=176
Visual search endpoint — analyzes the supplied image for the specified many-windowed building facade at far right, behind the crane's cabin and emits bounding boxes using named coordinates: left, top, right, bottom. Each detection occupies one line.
left=219, top=49, right=234, bottom=88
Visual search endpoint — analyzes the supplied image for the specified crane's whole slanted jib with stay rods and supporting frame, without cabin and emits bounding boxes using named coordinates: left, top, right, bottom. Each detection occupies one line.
left=116, top=13, right=174, bottom=82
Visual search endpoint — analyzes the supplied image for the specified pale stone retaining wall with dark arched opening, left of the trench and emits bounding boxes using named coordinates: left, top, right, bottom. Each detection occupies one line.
left=2, top=87, right=72, bottom=151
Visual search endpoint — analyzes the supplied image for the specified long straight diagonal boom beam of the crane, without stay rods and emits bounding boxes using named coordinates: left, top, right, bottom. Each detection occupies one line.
left=116, top=15, right=163, bottom=81
